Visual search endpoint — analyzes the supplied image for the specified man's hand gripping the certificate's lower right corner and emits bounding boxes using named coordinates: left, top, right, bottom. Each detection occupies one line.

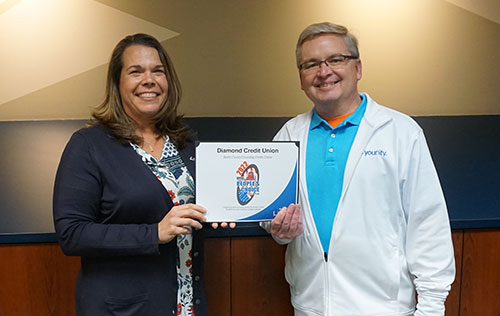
left=270, top=204, right=304, bottom=239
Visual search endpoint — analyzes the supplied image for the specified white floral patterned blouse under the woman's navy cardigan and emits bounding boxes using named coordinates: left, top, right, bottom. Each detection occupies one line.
left=130, top=136, right=194, bottom=316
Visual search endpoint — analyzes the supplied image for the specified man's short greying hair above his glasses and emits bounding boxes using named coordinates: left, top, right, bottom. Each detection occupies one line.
left=295, top=22, right=359, bottom=67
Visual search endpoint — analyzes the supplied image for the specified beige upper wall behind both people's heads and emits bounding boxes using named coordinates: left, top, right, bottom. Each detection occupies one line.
left=0, top=0, right=500, bottom=120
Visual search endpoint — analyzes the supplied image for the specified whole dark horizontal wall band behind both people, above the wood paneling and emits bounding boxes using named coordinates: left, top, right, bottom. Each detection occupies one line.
left=0, top=115, right=500, bottom=243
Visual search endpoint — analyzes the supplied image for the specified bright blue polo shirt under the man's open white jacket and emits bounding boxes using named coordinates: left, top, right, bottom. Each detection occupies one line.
left=306, top=95, right=366, bottom=256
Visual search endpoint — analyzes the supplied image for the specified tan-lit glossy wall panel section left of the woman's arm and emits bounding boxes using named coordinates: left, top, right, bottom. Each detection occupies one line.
left=0, top=121, right=82, bottom=236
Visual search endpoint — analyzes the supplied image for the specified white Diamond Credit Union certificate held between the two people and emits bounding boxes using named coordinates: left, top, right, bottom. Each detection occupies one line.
left=196, top=142, right=299, bottom=222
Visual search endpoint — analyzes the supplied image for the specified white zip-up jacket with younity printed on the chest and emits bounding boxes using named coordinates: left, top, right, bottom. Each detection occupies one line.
left=274, top=94, right=455, bottom=316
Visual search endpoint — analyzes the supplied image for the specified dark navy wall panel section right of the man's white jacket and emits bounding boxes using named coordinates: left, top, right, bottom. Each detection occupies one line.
left=416, top=115, right=500, bottom=228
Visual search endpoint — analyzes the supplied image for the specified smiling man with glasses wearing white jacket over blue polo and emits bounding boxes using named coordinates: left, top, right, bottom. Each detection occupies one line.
left=270, top=23, right=455, bottom=316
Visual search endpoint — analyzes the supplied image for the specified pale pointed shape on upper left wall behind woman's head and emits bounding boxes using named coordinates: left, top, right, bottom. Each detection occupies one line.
left=0, top=0, right=179, bottom=105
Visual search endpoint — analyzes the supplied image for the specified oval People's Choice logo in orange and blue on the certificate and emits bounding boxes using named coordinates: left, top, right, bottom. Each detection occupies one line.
left=236, top=161, right=260, bottom=205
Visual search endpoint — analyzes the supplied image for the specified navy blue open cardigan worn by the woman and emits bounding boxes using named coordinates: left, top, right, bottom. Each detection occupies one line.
left=53, top=127, right=207, bottom=316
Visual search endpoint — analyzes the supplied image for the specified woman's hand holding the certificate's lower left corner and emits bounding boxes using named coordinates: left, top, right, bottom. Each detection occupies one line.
left=158, top=203, right=207, bottom=244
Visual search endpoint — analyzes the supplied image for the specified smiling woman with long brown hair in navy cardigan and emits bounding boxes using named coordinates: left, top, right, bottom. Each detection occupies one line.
left=53, top=34, right=207, bottom=316
